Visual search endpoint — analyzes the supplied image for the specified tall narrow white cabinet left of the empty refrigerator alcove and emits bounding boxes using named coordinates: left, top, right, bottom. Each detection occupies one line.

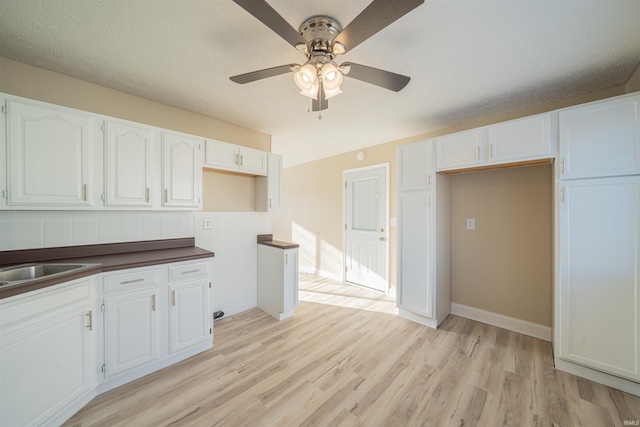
left=397, top=140, right=451, bottom=328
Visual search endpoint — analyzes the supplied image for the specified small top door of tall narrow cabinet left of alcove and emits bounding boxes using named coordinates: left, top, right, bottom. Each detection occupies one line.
left=398, top=140, right=434, bottom=191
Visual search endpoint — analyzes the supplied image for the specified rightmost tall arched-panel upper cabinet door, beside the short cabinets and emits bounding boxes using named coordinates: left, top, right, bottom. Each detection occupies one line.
left=162, top=133, right=202, bottom=209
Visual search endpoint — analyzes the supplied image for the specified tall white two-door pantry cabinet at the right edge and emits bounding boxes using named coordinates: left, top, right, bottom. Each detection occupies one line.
left=554, top=94, right=640, bottom=394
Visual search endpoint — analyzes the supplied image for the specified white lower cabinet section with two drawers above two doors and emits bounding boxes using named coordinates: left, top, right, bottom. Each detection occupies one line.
left=98, top=259, right=213, bottom=392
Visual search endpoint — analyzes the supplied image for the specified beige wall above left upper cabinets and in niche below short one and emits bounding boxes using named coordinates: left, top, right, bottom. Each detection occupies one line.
left=0, top=57, right=271, bottom=211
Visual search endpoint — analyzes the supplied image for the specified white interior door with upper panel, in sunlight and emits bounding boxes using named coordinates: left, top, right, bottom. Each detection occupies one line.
left=344, top=165, right=389, bottom=292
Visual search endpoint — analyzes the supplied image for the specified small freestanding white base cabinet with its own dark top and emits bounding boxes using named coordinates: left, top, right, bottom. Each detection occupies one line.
left=258, top=244, right=298, bottom=320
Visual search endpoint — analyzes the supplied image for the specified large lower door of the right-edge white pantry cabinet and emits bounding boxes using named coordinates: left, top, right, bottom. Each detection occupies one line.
left=557, top=176, right=640, bottom=381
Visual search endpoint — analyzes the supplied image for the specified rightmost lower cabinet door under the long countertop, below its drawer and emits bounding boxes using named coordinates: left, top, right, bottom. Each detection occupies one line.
left=169, top=280, right=212, bottom=353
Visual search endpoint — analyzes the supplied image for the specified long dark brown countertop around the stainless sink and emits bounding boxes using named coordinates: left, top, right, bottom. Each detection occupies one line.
left=0, top=238, right=215, bottom=299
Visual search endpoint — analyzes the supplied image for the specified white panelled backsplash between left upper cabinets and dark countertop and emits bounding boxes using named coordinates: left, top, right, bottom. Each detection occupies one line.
left=0, top=211, right=195, bottom=251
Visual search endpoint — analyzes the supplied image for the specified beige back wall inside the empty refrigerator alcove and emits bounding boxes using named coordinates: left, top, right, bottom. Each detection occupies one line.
left=451, top=165, right=553, bottom=326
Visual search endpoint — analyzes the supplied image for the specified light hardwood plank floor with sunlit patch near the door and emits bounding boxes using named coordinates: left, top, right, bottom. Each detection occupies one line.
left=65, top=274, right=640, bottom=427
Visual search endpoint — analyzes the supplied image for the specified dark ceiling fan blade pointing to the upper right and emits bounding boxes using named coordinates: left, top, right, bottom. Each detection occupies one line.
left=333, top=0, right=424, bottom=51
